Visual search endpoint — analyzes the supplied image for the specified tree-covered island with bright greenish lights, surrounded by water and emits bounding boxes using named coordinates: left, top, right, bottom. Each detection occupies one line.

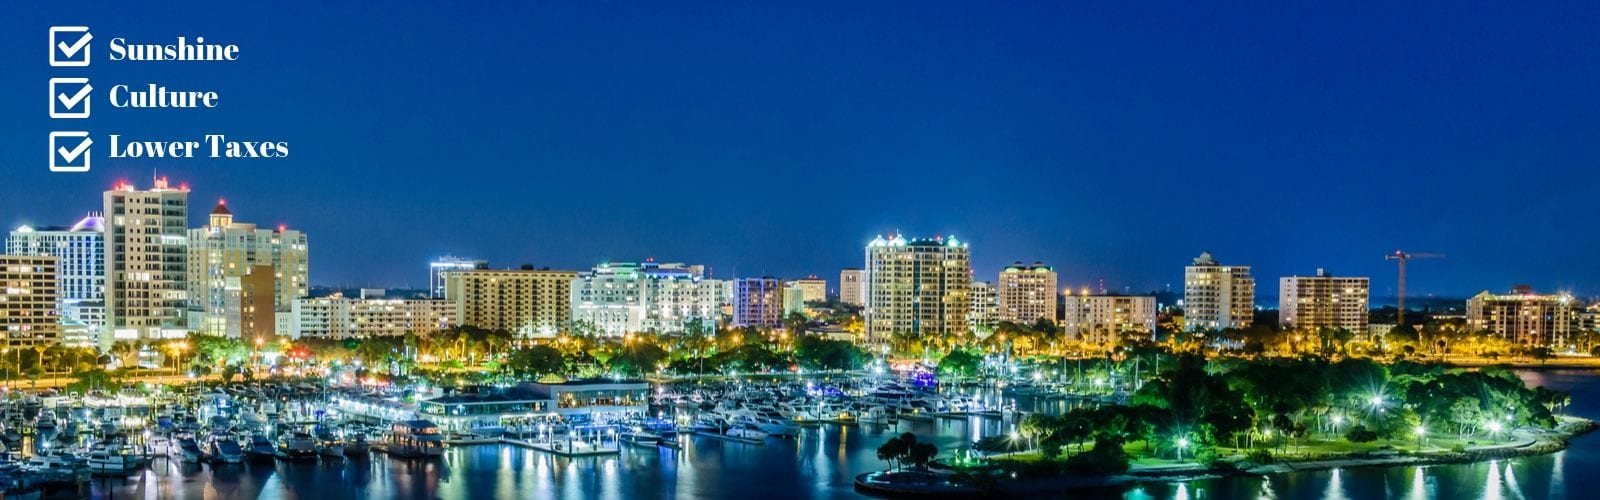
left=856, top=353, right=1595, bottom=497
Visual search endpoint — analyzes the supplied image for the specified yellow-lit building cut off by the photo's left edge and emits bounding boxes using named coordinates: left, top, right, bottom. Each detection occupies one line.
left=0, top=255, right=61, bottom=349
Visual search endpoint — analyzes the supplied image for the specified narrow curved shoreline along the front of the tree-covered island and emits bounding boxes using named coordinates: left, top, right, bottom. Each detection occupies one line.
left=856, top=417, right=1600, bottom=497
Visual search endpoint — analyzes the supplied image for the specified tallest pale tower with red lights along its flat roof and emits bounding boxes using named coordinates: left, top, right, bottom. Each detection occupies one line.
left=101, top=178, right=189, bottom=348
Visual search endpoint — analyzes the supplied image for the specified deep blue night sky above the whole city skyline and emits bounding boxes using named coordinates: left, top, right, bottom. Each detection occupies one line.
left=0, top=2, right=1600, bottom=301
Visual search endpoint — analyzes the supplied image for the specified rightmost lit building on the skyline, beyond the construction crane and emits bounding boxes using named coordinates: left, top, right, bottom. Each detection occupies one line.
left=1467, top=285, right=1581, bottom=348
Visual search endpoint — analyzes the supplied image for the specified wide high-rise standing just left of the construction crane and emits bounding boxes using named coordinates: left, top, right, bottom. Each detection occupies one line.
left=1278, top=269, right=1370, bottom=333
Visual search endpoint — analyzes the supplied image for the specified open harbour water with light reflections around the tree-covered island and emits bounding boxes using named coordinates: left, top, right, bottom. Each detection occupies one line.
left=90, top=370, right=1600, bottom=500
